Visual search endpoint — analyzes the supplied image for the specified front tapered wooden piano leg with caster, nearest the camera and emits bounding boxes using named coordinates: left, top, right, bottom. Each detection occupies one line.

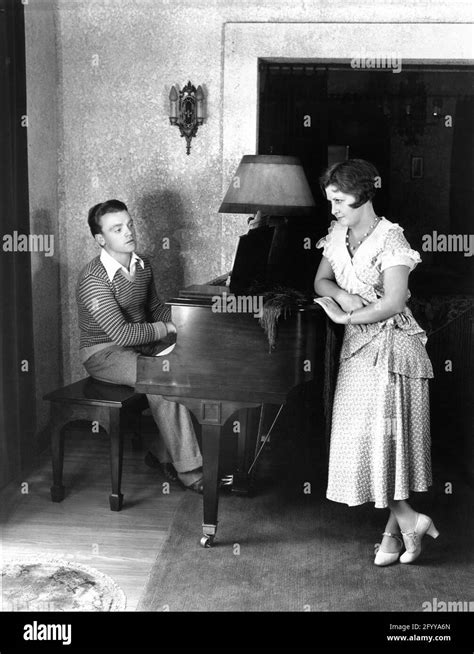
left=201, top=424, right=222, bottom=547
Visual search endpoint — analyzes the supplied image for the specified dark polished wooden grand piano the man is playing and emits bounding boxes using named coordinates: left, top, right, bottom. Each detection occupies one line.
left=136, top=284, right=327, bottom=547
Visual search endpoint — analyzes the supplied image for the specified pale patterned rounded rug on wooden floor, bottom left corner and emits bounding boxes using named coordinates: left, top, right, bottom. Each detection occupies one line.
left=1, top=557, right=126, bottom=611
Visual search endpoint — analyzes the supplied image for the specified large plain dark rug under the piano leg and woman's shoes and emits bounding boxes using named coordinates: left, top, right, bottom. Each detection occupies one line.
left=137, top=486, right=473, bottom=611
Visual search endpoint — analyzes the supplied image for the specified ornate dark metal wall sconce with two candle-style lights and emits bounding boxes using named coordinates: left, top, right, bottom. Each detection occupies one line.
left=170, top=82, right=205, bottom=154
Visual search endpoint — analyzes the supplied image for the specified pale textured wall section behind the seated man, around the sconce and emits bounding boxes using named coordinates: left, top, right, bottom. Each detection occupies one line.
left=59, top=0, right=231, bottom=378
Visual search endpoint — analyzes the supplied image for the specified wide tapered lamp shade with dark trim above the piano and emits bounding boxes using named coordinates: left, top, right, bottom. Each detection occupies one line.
left=219, top=154, right=315, bottom=216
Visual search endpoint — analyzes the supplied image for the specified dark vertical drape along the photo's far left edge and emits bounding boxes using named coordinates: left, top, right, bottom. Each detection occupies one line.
left=0, top=0, right=35, bottom=486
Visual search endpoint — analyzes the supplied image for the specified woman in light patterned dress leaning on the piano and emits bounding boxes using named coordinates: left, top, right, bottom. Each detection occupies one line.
left=314, top=159, right=438, bottom=565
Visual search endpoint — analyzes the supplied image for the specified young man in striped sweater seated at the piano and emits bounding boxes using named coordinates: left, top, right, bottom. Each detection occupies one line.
left=76, top=200, right=203, bottom=493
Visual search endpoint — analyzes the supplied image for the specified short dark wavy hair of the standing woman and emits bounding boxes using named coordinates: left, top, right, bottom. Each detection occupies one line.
left=319, top=159, right=379, bottom=209
